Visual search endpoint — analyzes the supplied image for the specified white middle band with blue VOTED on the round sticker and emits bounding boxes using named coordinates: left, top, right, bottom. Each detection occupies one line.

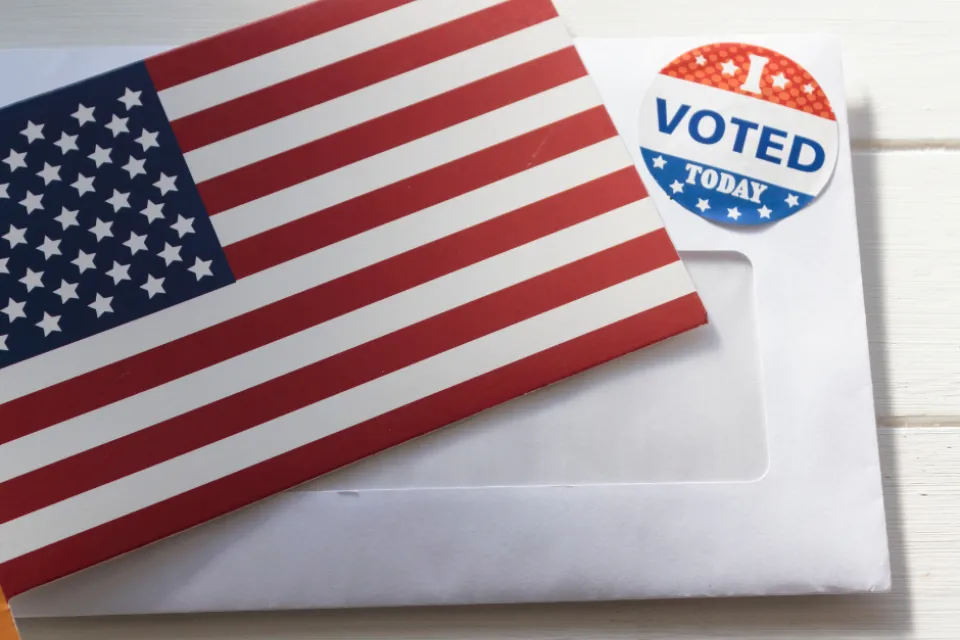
left=640, top=75, right=838, bottom=195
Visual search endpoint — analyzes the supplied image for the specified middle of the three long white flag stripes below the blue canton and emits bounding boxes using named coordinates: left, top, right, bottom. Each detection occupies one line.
left=0, top=198, right=662, bottom=482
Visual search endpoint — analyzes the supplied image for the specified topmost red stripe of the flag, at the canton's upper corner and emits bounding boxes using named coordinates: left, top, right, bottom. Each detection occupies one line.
left=146, top=0, right=413, bottom=91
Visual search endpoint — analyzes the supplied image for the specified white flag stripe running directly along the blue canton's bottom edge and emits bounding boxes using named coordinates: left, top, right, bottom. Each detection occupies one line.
left=0, top=138, right=633, bottom=403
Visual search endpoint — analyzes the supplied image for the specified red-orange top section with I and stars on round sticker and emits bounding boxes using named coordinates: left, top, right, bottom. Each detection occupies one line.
left=660, top=42, right=837, bottom=120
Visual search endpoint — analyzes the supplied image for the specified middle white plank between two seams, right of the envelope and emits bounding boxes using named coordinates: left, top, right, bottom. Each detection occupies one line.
left=853, top=151, right=960, bottom=418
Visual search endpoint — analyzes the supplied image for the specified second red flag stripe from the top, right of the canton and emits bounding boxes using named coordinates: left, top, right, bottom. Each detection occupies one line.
left=172, top=0, right=557, bottom=152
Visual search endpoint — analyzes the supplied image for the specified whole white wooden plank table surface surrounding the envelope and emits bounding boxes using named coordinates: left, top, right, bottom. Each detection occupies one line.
left=7, top=0, right=960, bottom=640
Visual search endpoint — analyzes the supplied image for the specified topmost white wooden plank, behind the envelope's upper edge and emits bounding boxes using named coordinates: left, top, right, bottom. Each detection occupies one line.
left=0, top=0, right=960, bottom=141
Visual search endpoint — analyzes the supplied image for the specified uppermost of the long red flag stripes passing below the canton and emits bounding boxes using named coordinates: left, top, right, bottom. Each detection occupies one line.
left=0, top=168, right=642, bottom=444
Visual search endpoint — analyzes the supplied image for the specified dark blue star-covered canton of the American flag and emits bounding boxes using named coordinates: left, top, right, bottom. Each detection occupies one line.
left=0, top=63, right=234, bottom=368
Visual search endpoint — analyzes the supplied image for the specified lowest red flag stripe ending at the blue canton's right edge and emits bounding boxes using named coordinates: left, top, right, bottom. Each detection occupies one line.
left=224, top=107, right=616, bottom=279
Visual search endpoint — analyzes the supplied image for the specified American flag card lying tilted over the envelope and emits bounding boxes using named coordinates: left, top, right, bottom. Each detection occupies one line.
left=0, top=0, right=705, bottom=596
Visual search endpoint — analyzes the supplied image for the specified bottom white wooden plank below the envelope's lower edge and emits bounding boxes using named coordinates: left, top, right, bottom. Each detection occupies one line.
left=15, top=427, right=960, bottom=640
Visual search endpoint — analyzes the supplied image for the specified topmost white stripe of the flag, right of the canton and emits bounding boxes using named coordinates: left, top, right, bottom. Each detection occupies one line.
left=160, top=0, right=504, bottom=120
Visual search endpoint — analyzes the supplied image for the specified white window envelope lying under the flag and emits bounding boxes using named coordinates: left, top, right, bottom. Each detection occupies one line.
left=9, top=36, right=890, bottom=617
